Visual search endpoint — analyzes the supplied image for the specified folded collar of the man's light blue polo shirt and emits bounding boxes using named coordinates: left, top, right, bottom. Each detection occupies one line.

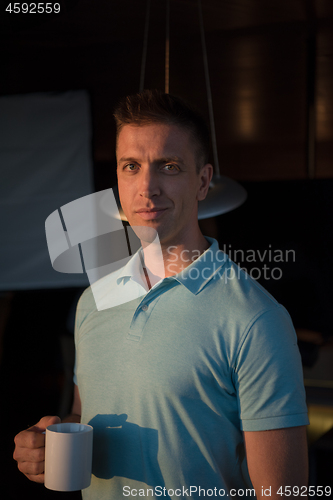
left=117, top=236, right=228, bottom=295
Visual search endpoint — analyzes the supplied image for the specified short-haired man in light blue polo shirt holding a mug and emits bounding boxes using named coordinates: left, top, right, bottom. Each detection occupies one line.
left=14, top=91, right=308, bottom=500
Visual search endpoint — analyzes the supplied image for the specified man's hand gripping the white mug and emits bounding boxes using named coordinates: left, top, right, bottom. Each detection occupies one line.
left=13, top=417, right=61, bottom=483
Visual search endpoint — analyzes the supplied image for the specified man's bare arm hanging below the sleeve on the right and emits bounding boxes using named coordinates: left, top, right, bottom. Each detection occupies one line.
left=244, top=426, right=308, bottom=500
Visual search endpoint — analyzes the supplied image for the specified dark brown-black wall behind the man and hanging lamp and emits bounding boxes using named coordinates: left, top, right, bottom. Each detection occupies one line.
left=0, top=0, right=333, bottom=499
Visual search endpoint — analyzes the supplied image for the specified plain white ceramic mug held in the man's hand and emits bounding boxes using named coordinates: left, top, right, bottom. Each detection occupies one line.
left=44, top=423, right=93, bottom=491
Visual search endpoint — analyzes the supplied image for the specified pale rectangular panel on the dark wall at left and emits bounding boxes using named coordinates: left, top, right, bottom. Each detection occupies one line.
left=0, top=91, right=94, bottom=290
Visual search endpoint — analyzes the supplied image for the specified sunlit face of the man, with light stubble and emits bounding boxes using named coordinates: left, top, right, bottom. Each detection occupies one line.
left=117, top=123, right=212, bottom=246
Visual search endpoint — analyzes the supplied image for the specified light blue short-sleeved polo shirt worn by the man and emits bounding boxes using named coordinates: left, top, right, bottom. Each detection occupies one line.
left=75, top=238, right=308, bottom=500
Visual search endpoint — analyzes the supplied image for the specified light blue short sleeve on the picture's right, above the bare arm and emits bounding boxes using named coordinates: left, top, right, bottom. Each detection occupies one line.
left=234, top=306, right=309, bottom=431
